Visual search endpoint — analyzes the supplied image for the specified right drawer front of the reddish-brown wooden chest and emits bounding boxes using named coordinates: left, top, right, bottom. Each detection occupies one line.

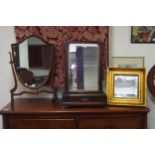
left=79, top=115, right=145, bottom=129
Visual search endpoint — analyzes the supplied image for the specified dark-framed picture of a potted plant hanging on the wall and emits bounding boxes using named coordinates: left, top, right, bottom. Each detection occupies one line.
left=131, top=26, right=155, bottom=43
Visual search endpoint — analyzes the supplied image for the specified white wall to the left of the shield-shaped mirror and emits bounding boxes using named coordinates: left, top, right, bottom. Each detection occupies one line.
left=0, top=26, right=15, bottom=128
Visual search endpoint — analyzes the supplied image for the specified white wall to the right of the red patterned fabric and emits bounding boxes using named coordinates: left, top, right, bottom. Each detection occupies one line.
left=109, top=26, right=155, bottom=128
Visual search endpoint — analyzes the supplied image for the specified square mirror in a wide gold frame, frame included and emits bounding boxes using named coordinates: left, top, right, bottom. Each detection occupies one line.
left=106, top=68, right=146, bottom=106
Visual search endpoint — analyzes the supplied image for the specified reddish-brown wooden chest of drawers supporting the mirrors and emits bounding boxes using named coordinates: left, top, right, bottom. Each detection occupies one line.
left=0, top=99, right=149, bottom=129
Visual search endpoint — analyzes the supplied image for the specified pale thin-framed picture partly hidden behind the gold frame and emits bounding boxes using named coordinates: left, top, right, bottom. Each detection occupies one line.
left=111, top=57, right=145, bottom=68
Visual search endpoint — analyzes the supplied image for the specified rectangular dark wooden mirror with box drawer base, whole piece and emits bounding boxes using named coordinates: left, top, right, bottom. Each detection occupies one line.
left=63, top=42, right=107, bottom=106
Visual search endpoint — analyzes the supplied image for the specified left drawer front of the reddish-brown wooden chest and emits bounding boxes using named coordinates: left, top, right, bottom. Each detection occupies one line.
left=7, top=119, right=76, bottom=129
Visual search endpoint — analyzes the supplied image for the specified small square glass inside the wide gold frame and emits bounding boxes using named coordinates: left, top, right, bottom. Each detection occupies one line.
left=114, top=75, right=138, bottom=99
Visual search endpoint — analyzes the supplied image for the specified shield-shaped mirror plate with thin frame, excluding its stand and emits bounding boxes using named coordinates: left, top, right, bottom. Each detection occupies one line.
left=12, top=36, right=54, bottom=88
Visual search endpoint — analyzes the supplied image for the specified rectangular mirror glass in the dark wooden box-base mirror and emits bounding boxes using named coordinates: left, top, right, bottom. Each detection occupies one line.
left=68, top=43, right=99, bottom=91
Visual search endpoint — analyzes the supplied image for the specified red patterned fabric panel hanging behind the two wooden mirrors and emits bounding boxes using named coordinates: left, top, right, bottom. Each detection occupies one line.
left=15, top=26, right=108, bottom=87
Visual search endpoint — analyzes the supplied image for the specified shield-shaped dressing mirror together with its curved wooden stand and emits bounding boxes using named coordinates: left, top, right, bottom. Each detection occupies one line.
left=10, top=35, right=55, bottom=105
